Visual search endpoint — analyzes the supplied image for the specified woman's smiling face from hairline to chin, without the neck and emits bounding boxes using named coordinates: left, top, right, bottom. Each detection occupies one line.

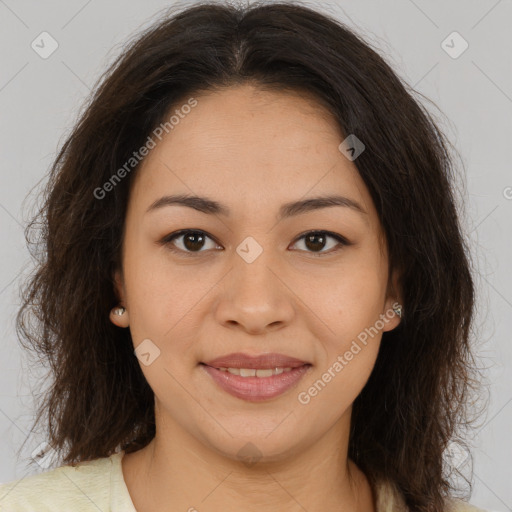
left=112, top=85, right=399, bottom=460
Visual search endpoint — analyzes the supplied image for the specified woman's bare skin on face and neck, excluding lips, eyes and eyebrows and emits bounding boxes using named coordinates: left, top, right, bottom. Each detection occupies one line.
left=111, top=85, right=400, bottom=512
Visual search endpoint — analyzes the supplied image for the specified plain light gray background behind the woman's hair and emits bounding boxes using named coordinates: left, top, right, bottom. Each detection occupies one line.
left=0, top=0, right=512, bottom=511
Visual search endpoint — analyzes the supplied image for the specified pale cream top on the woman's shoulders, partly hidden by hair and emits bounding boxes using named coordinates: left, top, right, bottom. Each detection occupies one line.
left=0, top=452, right=483, bottom=512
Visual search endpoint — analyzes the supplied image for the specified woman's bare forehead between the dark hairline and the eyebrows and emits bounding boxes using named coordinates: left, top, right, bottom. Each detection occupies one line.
left=128, top=85, right=376, bottom=226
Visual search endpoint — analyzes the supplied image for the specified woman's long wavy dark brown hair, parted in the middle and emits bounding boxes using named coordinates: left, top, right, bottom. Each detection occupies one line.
left=17, top=2, right=484, bottom=511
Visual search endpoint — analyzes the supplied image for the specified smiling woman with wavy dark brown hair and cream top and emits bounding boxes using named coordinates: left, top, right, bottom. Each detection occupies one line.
left=0, top=3, right=486, bottom=512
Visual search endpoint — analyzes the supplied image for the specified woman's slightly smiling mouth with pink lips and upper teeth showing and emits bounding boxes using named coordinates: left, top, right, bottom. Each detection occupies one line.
left=200, top=353, right=313, bottom=402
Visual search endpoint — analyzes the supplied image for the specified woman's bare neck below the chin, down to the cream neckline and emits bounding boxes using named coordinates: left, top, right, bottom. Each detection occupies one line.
left=122, top=414, right=375, bottom=512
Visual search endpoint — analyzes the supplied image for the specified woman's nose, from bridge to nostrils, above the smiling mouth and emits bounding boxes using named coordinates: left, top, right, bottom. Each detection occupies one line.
left=215, top=247, right=295, bottom=334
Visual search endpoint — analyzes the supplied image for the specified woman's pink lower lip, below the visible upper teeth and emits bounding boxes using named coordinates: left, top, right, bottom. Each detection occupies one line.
left=201, top=364, right=311, bottom=402
